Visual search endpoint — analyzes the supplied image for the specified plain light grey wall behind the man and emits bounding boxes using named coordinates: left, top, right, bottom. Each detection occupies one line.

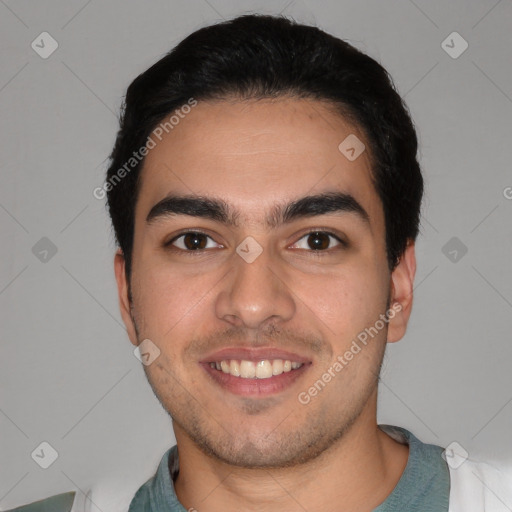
left=0, top=0, right=512, bottom=510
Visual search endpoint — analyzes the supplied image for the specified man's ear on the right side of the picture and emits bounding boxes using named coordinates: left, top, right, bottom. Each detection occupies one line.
left=387, top=240, right=416, bottom=343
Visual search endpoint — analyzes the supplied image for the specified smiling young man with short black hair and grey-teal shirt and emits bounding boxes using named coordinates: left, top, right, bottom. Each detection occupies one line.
left=104, top=15, right=505, bottom=512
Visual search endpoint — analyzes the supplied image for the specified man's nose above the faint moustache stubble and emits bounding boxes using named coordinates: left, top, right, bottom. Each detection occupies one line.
left=215, top=242, right=296, bottom=329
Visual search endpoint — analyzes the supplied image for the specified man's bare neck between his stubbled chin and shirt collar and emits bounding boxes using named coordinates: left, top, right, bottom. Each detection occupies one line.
left=174, top=393, right=409, bottom=512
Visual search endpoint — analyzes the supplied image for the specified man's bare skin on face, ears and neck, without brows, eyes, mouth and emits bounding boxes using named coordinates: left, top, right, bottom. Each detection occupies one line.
left=115, top=98, right=416, bottom=512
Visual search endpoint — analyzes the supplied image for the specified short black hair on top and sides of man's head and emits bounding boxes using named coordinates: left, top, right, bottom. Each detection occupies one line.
left=105, top=14, right=423, bottom=280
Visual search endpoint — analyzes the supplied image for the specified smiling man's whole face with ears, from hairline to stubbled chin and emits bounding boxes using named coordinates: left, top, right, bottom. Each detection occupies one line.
left=115, top=98, right=414, bottom=467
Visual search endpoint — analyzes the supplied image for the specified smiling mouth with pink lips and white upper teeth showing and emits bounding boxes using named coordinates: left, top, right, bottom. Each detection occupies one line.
left=200, top=349, right=312, bottom=397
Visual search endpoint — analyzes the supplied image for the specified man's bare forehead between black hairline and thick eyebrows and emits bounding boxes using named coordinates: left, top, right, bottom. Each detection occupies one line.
left=137, top=98, right=382, bottom=230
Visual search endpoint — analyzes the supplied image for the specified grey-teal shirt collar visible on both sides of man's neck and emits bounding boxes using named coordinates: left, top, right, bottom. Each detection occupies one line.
left=128, top=425, right=450, bottom=512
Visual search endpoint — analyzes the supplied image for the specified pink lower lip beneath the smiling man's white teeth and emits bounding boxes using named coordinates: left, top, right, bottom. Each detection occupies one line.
left=201, top=363, right=311, bottom=397
